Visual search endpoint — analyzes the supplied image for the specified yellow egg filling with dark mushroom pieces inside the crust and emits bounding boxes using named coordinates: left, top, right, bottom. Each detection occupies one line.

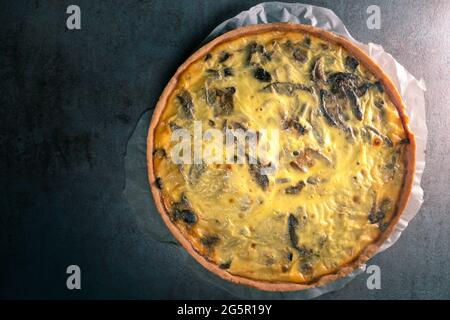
left=154, top=32, right=407, bottom=283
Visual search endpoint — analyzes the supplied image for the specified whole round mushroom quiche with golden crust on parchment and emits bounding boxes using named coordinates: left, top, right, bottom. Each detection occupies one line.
left=147, top=23, right=415, bottom=291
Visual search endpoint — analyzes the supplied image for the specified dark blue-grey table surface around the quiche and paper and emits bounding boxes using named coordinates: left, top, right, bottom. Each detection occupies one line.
left=0, top=0, right=450, bottom=299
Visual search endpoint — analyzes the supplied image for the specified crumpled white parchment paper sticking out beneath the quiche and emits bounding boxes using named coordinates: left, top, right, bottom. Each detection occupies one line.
left=124, top=2, right=427, bottom=299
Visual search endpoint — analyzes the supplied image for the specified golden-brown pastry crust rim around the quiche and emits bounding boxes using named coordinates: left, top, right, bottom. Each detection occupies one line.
left=147, top=23, right=415, bottom=291
